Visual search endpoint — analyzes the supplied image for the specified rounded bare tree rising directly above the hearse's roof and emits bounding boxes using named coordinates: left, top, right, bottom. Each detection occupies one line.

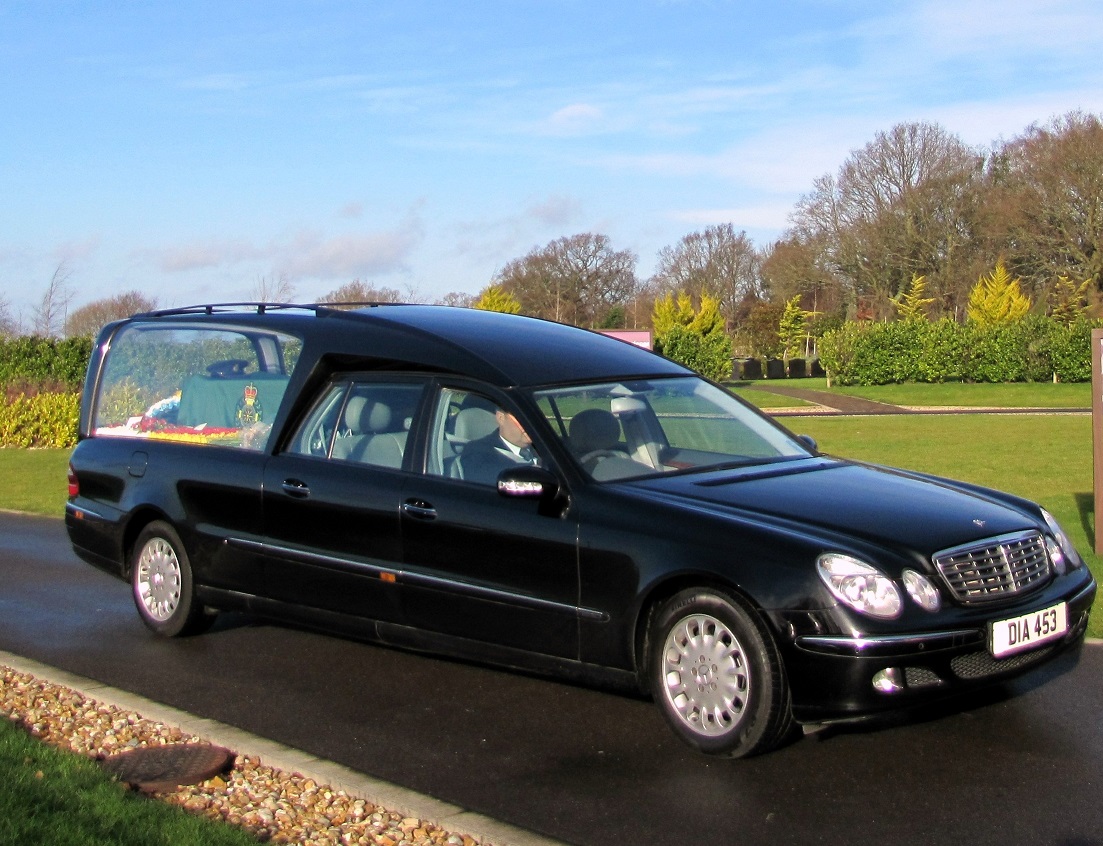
left=492, top=233, right=639, bottom=328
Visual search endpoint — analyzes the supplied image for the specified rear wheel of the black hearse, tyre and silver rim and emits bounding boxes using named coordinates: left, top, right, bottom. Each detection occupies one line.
left=130, top=521, right=214, bottom=638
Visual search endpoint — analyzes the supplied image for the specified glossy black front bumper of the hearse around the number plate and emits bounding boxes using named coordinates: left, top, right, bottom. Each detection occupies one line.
left=782, top=577, right=1096, bottom=722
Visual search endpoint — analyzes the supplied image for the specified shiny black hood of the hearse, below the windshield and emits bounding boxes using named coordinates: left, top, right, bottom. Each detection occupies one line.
left=639, top=457, right=1039, bottom=558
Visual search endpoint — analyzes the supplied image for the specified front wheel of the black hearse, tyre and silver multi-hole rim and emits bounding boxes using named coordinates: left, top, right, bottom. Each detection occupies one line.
left=647, top=588, right=793, bottom=758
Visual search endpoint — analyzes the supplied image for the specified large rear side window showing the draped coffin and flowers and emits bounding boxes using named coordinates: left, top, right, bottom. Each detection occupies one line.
left=93, top=323, right=301, bottom=449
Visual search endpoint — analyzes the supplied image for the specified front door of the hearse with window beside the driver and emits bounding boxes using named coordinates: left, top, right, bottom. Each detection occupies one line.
left=401, top=387, right=579, bottom=658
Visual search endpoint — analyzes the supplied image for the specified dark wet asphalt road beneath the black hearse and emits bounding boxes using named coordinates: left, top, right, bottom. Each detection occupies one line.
left=0, top=514, right=1103, bottom=846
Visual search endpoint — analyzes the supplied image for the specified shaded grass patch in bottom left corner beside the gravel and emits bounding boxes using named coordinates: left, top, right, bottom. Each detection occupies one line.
left=0, top=719, right=257, bottom=846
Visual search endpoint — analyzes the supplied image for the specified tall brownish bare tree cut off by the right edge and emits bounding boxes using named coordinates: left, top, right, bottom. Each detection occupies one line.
left=987, top=111, right=1103, bottom=299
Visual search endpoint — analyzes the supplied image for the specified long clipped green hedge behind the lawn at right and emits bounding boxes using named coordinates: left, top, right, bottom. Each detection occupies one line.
left=820, top=315, right=1103, bottom=385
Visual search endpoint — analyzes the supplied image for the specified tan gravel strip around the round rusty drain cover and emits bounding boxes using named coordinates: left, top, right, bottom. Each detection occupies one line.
left=0, top=666, right=478, bottom=846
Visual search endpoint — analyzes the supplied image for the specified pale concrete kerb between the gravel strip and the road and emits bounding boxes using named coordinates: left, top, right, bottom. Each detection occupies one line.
left=0, top=651, right=563, bottom=846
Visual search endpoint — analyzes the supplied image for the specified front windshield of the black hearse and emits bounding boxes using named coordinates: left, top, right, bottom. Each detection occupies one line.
left=534, top=376, right=810, bottom=481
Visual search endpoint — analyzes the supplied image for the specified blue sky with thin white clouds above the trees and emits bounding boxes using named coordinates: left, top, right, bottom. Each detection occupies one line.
left=0, top=0, right=1103, bottom=319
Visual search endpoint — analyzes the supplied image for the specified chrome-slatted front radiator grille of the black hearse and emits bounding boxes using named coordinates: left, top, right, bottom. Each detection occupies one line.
left=934, top=532, right=1050, bottom=604
